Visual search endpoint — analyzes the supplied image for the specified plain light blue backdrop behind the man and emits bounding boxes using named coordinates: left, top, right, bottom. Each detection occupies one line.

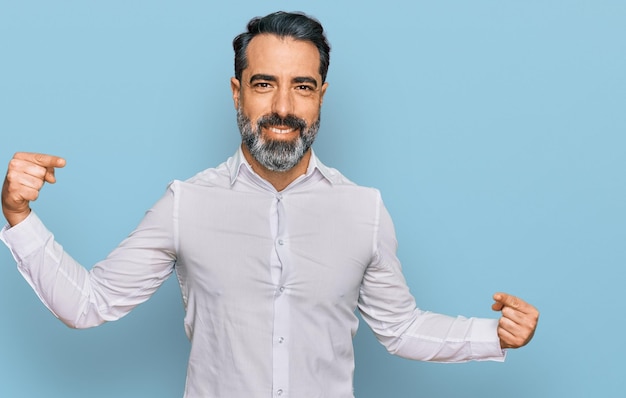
left=0, top=0, right=626, bottom=398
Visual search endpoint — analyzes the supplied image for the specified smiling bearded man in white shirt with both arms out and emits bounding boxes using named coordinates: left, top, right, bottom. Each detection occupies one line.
left=1, top=12, right=539, bottom=398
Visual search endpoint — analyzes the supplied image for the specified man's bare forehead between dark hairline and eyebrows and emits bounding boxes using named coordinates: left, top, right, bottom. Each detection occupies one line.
left=243, top=34, right=321, bottom=81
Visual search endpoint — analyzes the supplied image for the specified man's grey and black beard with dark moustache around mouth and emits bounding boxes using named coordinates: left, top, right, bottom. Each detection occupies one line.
left=237, top=108, right=320, bottom=171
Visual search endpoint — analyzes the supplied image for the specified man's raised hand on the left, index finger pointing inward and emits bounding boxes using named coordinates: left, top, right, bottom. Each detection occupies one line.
left=2, top=152, right=65, bottom=226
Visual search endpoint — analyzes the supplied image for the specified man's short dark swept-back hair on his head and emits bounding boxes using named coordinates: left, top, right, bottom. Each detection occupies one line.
left=233, top=11, right=330, bottom=83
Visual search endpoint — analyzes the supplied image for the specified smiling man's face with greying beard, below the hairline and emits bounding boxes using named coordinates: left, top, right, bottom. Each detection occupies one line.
left=231, top=34, right=327, bottom=171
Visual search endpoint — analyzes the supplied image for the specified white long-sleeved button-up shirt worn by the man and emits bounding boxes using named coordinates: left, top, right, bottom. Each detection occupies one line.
left=0, top=150, right=504, bottom=398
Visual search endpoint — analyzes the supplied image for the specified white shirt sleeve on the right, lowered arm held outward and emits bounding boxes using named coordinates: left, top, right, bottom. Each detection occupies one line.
left=359, top=200, right=505, bottom=362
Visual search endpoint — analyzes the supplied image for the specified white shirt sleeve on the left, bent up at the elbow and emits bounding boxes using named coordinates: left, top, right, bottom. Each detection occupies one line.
left=0, top=189, right=176, bottom=328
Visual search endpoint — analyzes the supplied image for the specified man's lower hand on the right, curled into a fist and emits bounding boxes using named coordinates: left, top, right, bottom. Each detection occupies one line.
left=491, top=293, right=539, bottom=348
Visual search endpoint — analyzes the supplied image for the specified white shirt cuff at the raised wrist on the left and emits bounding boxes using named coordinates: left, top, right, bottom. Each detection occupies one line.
left=0, top=210, right=52, bottom=263
